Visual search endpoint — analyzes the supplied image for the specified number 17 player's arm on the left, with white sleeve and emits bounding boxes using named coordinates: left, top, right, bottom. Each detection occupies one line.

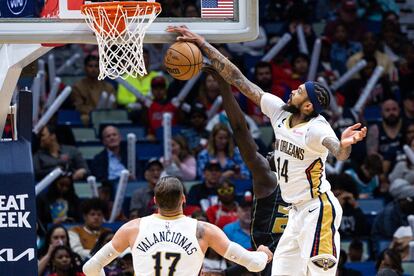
left=82, top=220, right=139, bottom=276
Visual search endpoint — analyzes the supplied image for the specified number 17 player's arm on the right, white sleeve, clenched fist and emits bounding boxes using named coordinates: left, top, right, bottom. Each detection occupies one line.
left=197, top=221, right=273, bottom=272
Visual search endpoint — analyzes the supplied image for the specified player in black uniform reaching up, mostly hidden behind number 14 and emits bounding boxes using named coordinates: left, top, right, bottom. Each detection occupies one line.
left=204, top=67, right=288, bottom=276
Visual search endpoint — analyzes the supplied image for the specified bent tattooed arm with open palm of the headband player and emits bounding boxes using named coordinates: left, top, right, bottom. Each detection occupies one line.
left=322, top=123, right=367, bottom=160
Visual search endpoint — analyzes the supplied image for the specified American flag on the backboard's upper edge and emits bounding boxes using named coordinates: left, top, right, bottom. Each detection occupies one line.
left=201, top=0, right=234, bottom=18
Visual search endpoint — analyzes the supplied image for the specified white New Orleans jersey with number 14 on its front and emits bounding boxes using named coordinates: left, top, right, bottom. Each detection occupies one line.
left=260, top=93, right=338, bottom=204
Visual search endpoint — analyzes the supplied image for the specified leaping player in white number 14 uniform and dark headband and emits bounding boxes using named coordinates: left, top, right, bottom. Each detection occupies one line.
left=167, top=26, right=367, bottom=276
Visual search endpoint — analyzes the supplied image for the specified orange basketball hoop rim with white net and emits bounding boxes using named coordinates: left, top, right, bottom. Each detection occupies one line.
left=81, top=1, right=161, bottom=80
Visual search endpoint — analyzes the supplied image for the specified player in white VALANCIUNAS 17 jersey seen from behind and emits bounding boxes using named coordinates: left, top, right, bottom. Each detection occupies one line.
left=83, top=176, right=272, bottom=276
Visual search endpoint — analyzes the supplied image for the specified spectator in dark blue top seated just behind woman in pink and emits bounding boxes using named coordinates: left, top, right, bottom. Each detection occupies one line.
left=180, top=103, right=209, bottom=156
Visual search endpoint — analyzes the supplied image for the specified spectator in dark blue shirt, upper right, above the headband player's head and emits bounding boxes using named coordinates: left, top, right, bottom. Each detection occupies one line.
left=330, top=23, right=362, bottom=75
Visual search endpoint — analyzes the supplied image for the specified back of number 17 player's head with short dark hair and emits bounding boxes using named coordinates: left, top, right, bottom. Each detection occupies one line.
left=154, top=176, right=184, bottom=210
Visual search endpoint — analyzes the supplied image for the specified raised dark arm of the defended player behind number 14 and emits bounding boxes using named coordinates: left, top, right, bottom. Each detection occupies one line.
left=203, top=66, right=277, bottom=198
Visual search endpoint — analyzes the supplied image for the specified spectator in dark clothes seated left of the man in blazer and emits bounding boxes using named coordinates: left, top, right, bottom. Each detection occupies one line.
left=33, top=125, right=88, bottom=180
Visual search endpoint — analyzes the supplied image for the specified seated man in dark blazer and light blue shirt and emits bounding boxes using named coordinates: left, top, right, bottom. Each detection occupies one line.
left=91, top=125, right=136, bottom=182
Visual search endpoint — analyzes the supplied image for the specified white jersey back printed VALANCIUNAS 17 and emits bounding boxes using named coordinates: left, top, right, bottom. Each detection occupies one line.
left=131, top=214, right=204, bottom=276
